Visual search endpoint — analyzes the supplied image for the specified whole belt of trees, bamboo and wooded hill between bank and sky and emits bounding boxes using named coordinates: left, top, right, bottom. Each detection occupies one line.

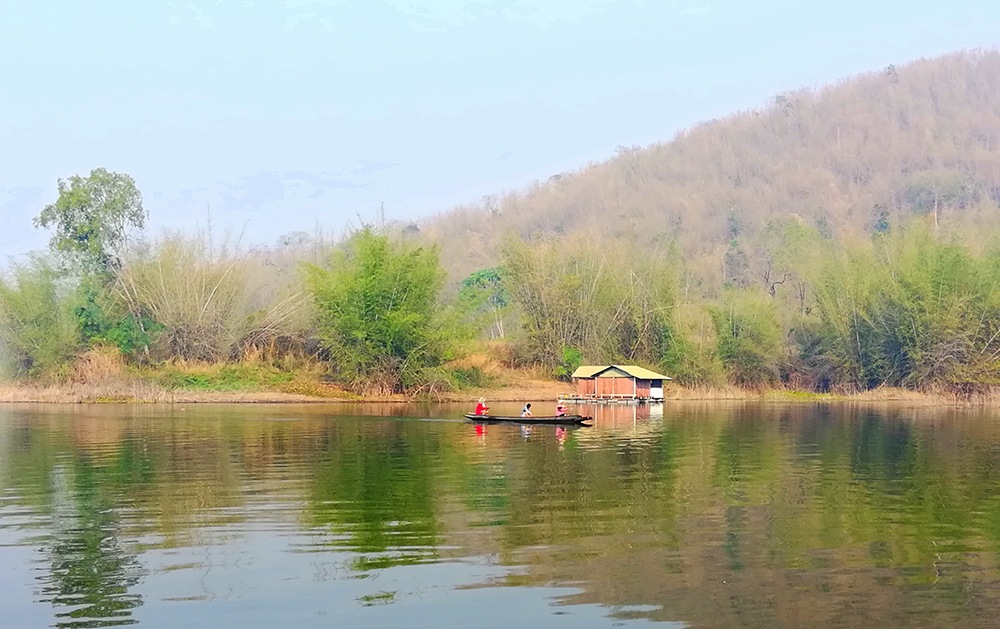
left=0, top=52, right=1000, bottom=396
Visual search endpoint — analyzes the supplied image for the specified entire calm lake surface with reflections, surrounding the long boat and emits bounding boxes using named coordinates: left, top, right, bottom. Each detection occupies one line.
left=0, top=404, right=1000, bottom=629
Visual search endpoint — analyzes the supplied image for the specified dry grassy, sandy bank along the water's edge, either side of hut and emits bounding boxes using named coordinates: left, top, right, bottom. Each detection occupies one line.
left=0, top=348, right=976, bottom=407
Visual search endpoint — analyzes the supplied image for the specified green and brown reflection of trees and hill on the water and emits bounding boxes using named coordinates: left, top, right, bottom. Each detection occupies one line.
left=0, top=405, right=1000, bottom=627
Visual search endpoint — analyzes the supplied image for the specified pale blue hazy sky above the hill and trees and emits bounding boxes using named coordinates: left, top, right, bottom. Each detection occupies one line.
left=0, top=0, right=1000, bottom=259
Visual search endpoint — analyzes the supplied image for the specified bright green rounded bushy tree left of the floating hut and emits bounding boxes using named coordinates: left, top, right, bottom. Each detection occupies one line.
left=307, top=227, right=446, bottom=394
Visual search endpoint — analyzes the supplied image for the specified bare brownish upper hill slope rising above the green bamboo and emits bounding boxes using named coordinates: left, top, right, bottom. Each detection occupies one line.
left=418, top=50, right=1000, bottom=286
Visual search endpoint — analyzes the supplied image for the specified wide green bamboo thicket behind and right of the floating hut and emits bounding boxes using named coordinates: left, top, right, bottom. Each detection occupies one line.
left=504, top=217, right=1000, bottom=394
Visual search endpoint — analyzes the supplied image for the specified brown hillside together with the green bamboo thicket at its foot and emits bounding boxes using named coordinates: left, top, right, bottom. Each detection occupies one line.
left=422, top=51, right=1000, bottom=392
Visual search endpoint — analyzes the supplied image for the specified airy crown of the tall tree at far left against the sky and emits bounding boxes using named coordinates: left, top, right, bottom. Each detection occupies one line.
left=34, top=168, right=147, bottom=273
